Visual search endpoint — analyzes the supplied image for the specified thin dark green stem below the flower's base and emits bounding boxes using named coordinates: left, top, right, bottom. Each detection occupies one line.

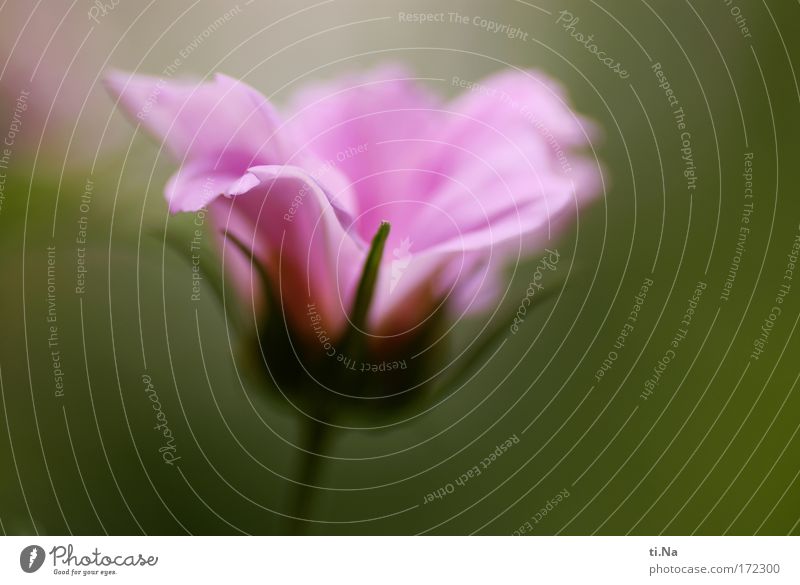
left=287, top=417, right=330, bottom=535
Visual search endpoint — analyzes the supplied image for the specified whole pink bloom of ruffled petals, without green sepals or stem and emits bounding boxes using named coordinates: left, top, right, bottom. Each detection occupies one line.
left=107, top=67, right=599, bottom=352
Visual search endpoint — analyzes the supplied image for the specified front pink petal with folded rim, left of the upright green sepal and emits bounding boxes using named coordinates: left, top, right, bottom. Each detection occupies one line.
left=215, top=165, right=365, bottom=339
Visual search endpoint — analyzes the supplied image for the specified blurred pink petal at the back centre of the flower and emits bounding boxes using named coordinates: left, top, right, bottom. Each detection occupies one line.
left=287, top=66, right=440, bottom=241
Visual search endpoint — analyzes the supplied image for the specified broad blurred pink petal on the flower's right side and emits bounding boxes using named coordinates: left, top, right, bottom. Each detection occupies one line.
left=376, top=72, right=600, bottom=322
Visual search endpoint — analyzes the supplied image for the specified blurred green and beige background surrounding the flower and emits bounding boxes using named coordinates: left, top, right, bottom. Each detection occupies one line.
left=0, top=0, right=800, bottom=534
